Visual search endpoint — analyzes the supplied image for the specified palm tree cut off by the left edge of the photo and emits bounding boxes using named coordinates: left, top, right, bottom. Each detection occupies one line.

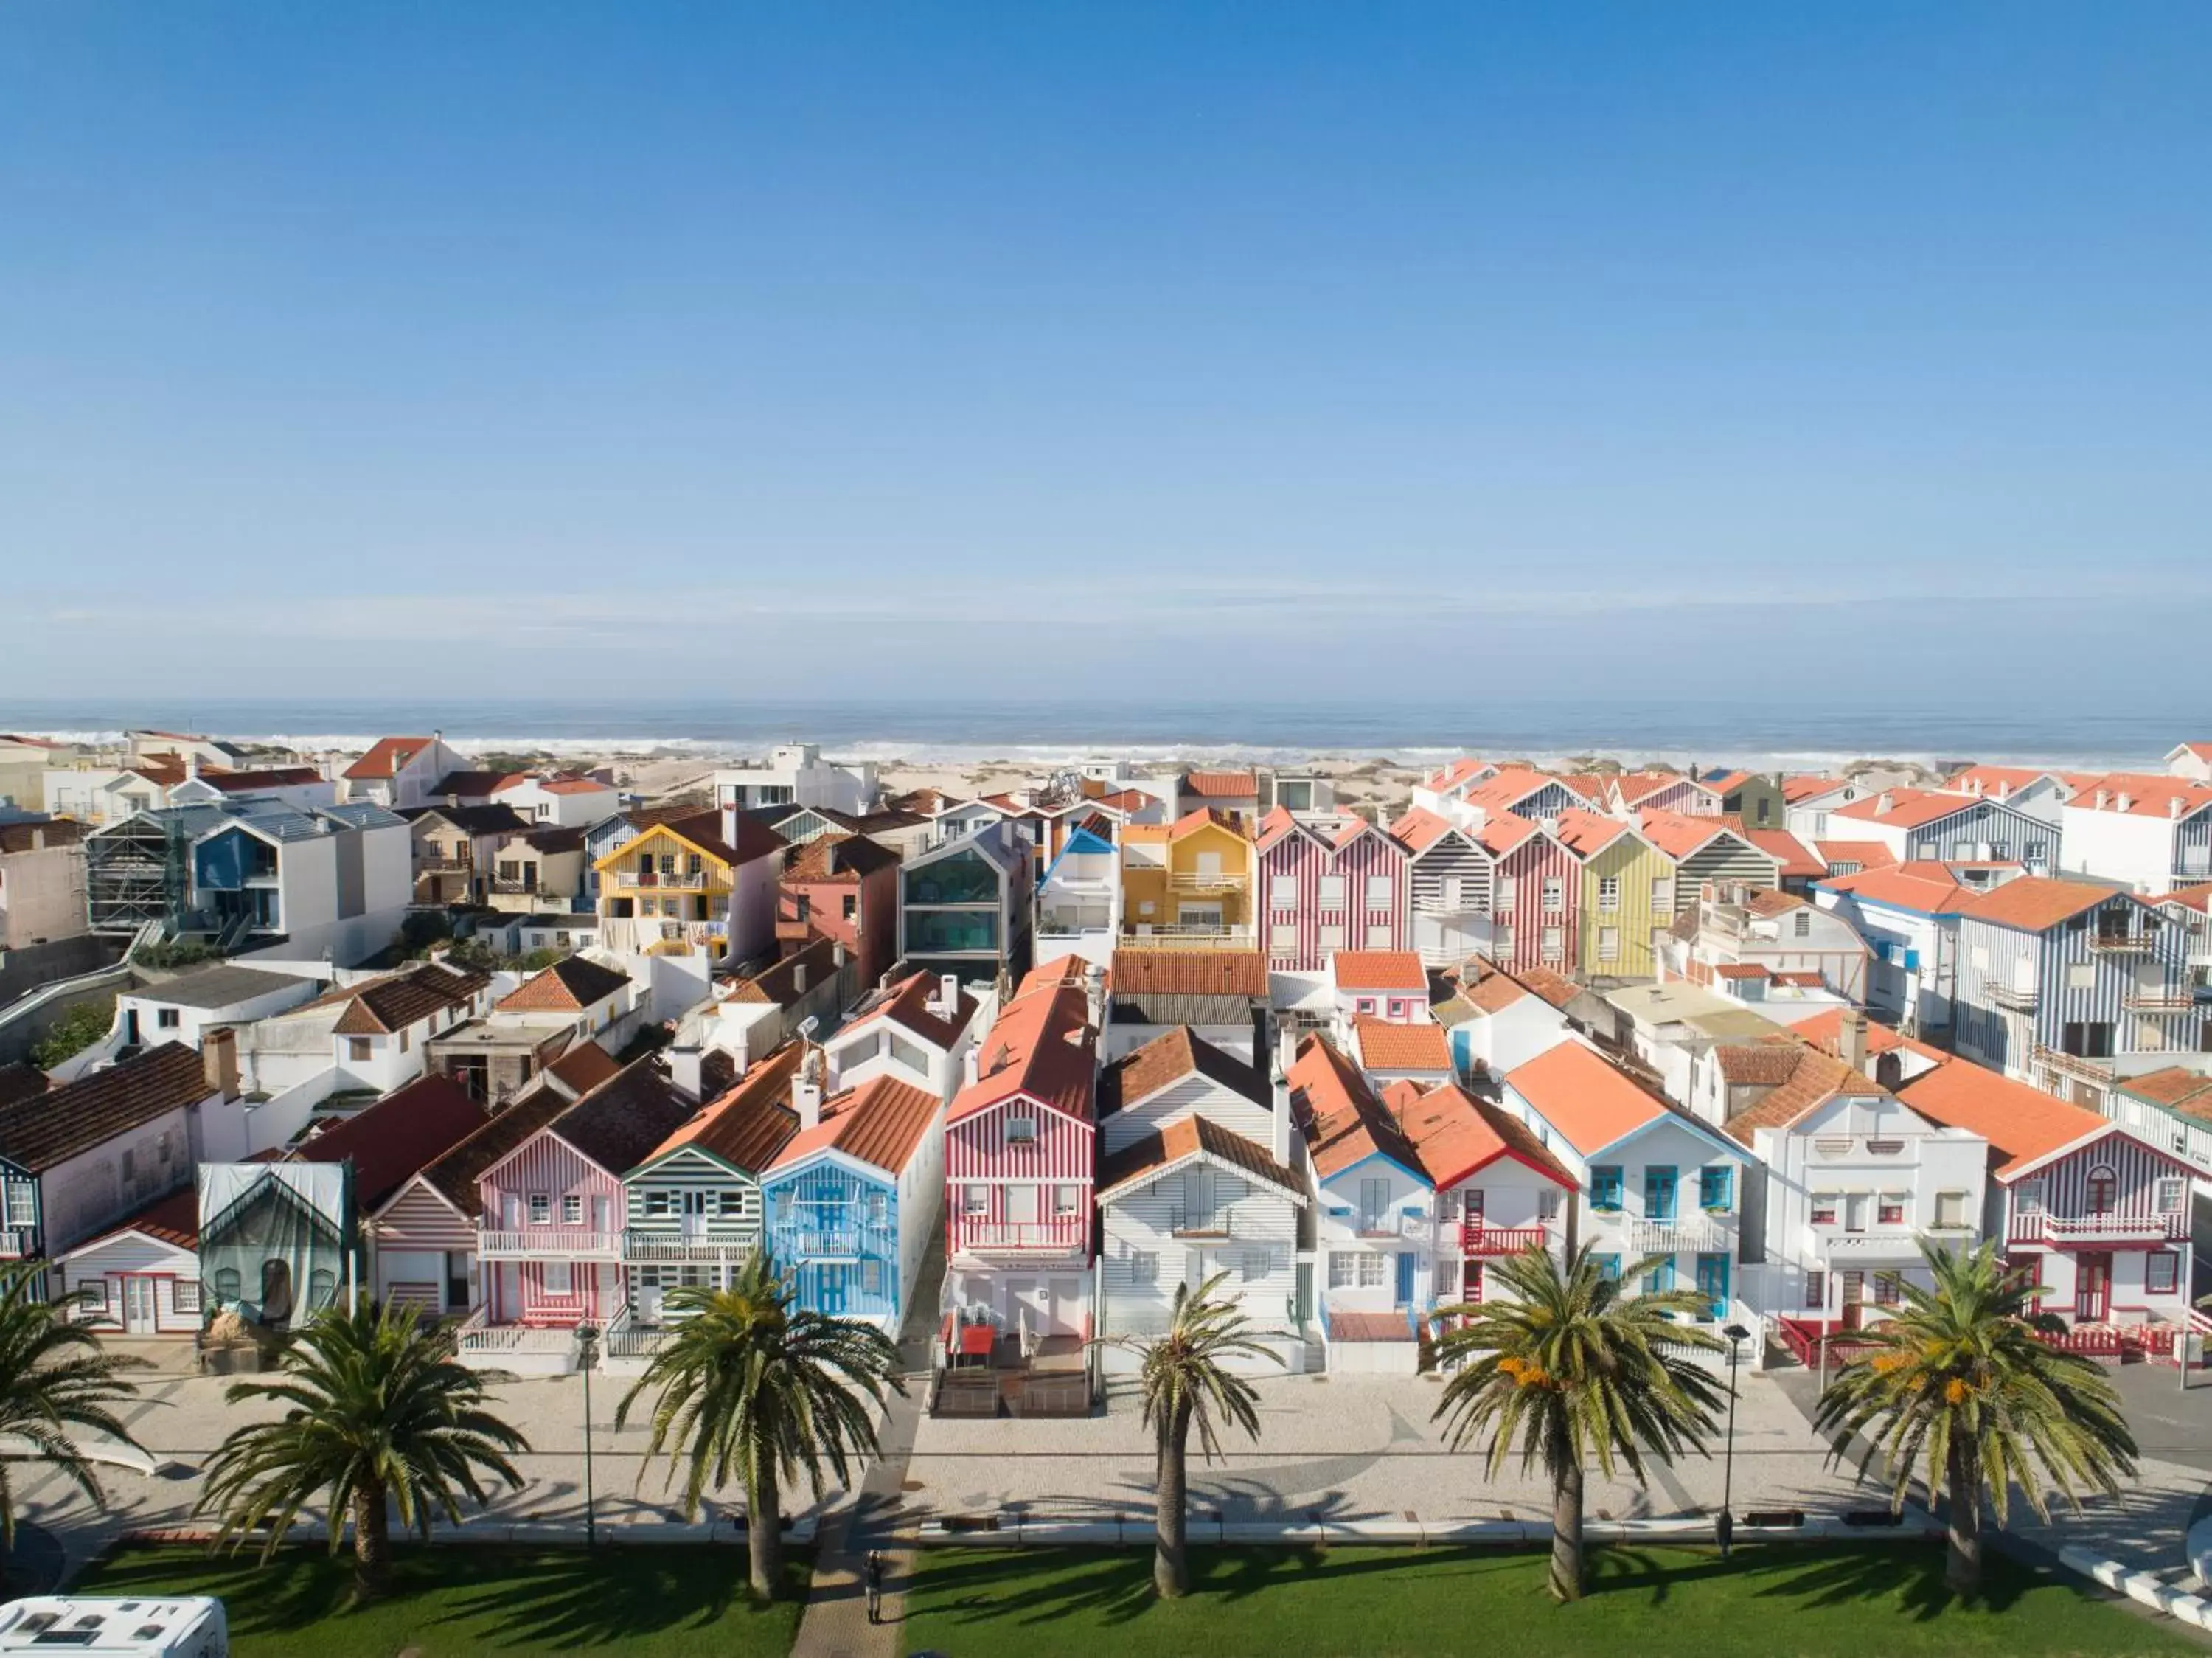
left=0, top=1262, right=142, bottom=1561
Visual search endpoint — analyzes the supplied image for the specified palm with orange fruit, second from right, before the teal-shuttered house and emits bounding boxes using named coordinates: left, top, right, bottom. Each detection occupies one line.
left=1436, top=1246, right=1728, bottom=1600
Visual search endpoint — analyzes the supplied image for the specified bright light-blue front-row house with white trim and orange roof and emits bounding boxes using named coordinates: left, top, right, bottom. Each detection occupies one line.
left=761, top=1076, right=945, bottom=1335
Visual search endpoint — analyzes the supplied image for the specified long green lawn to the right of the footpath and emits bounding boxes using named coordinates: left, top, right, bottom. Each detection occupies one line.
left=905, top=1545, right=2201, bottom=1658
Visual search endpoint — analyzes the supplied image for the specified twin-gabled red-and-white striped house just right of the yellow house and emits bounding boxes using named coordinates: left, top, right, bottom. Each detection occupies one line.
left=1254, top=805, right=1409, bottom=972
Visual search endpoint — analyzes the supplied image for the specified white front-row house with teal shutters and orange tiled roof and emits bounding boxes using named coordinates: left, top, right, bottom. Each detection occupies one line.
left=1504, top=1043, right=1759, bottom=1346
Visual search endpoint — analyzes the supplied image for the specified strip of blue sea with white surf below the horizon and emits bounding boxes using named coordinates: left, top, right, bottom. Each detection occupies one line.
left=0, top=693, right=2212, bottom=768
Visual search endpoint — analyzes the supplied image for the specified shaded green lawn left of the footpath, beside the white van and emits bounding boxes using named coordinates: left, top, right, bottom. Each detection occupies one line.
left=71, top=1543, right=807, bottom=1658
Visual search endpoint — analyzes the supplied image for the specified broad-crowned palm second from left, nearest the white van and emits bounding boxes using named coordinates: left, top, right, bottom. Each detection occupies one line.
left=195, top=1300, right=529, bottom=1598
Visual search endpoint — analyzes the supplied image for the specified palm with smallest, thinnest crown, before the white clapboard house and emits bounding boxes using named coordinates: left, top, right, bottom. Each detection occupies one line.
left=1104, top=1273, right=1283, bottom=1600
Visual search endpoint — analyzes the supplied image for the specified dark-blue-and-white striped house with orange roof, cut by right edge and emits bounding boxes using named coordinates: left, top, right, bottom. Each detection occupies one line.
left=1953, top=877, right=2201, bottom=1107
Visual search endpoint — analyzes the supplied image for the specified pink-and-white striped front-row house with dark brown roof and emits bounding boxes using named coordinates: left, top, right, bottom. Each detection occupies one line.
left=460, top=1058, right=692, bottom=1373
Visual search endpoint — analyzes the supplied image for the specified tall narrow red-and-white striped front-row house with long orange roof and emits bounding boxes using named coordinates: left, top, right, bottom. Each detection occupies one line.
left=945, top=957, right=1104, bottom=1337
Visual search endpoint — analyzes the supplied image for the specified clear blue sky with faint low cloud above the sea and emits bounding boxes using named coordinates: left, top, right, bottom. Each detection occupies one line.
left=0, top=0, right=2212, bottom=712
